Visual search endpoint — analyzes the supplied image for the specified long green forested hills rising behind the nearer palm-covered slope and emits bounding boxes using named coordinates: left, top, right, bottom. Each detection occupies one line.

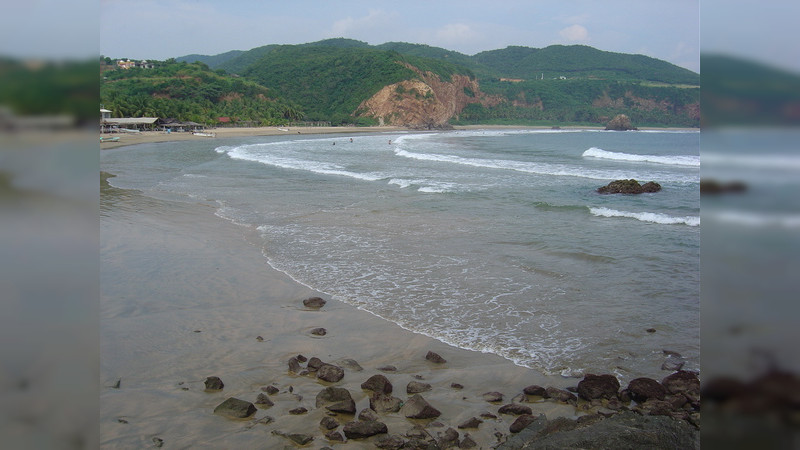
left=162, top=38, right=700, bottom=126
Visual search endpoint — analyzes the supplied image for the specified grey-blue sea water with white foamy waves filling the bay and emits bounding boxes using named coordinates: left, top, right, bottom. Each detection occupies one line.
left=101, top=130, right=700, bottom=379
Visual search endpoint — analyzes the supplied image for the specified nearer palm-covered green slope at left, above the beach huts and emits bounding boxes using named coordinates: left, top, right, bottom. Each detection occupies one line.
left=100, top=60, right=302, bottom=125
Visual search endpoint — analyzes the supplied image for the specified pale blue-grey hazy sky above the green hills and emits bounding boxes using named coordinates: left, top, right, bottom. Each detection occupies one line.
left=99, top=0, right=700, bottom=72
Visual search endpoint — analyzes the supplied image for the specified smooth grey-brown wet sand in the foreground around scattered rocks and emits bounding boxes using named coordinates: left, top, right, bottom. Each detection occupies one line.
left=100, top=171, right=579, bottom=448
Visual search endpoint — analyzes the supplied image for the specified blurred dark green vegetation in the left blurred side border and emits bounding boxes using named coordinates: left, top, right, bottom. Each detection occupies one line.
left=0, top=59, right=97, bottom=124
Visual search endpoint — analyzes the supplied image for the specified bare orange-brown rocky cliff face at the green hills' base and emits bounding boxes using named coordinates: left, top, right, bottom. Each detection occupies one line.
left=354, top=65, right=501, bottom=129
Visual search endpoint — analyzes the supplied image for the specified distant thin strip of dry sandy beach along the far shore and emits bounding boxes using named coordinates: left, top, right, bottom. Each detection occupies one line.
left=100, top=125, right=699, bottom=150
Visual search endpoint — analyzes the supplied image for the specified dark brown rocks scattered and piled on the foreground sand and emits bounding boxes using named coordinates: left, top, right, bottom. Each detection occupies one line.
left=197, top=298, right=700, bottom=449
